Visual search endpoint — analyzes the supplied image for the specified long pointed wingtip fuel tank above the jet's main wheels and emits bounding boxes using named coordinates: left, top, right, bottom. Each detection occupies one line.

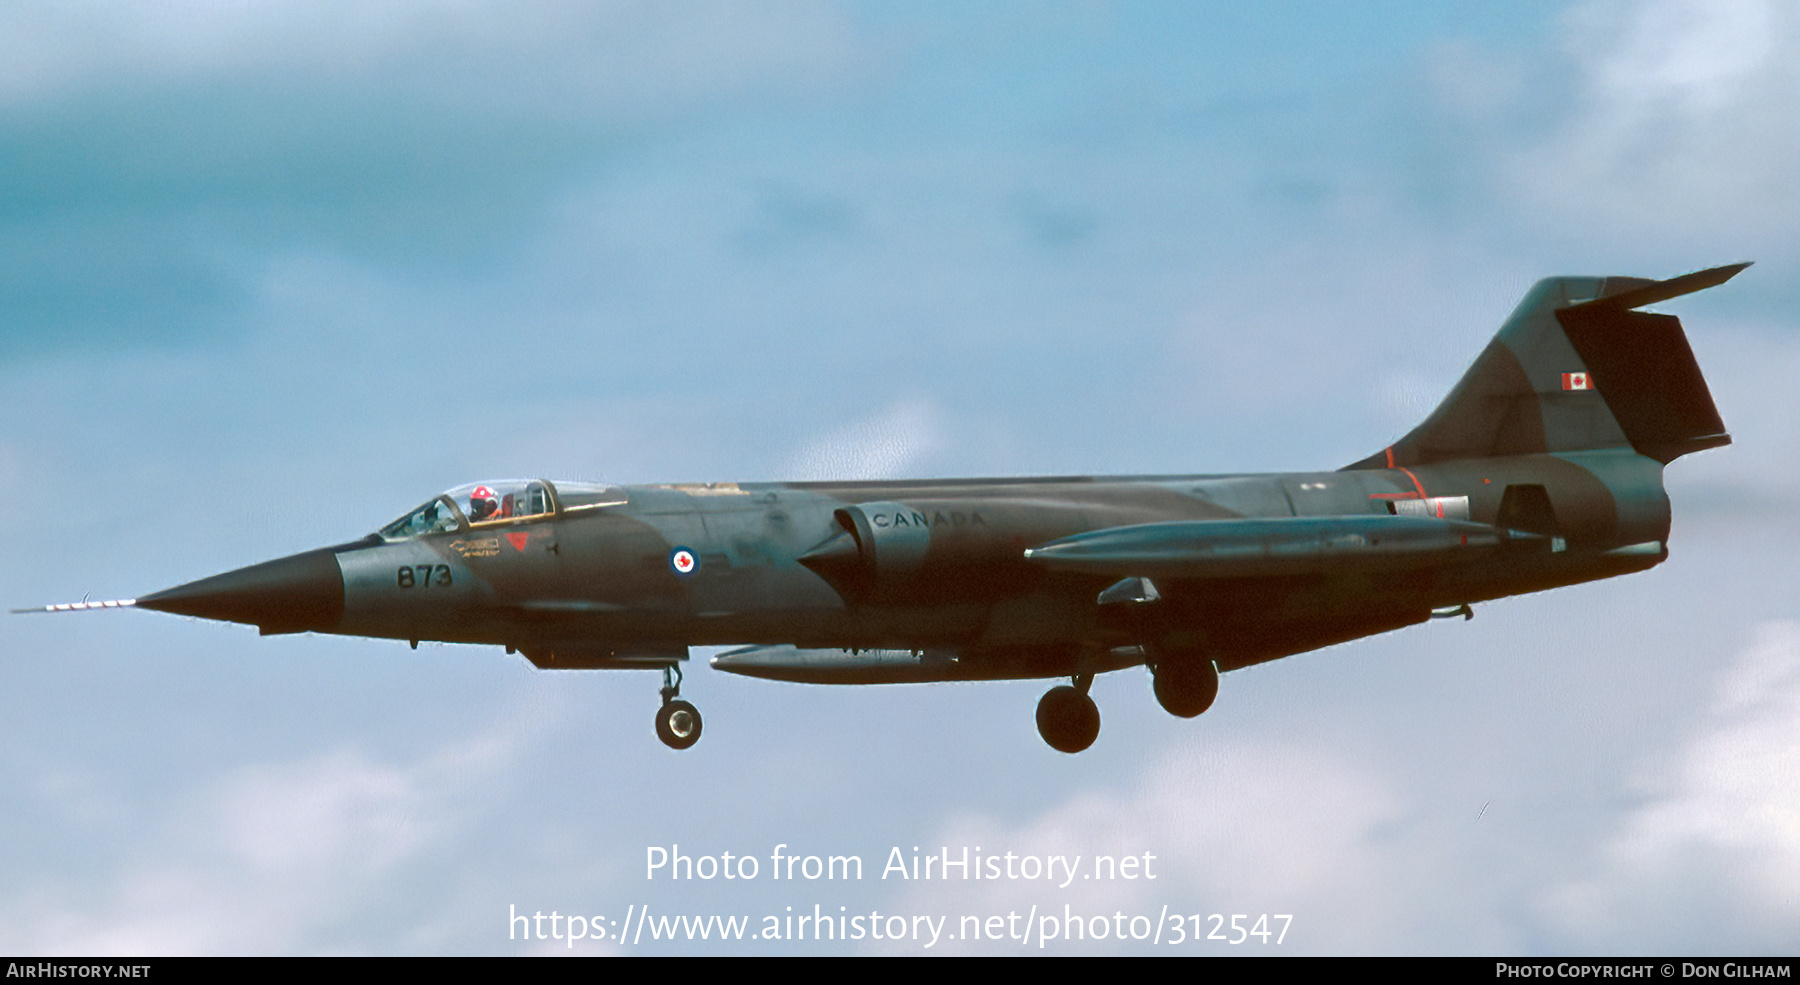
left=1024, top=515, right=1535, bottom=578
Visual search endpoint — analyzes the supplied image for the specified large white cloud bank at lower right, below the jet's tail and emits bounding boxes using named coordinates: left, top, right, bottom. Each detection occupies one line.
left=867, top=621, right=1800, bottom=953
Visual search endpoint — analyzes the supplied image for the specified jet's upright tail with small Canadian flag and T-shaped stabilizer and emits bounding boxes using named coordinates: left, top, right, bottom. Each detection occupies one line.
left=1346, top=263, right=1750, bottom=468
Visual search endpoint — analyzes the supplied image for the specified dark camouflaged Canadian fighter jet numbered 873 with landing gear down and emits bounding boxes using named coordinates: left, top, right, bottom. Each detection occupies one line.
left=17, top=263, right=1750, bottom=753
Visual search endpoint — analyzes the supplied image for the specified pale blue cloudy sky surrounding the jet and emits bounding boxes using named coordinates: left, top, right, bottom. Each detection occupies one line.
left=0, top=0, right=1800, bottom=954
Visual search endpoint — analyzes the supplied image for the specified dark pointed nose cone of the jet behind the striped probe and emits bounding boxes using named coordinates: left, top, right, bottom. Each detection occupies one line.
left=137, top=547, right=344, bottom=634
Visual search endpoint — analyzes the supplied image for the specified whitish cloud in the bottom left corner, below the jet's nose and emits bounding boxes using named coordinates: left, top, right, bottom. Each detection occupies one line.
left=0, top=716, right=520, bottom=954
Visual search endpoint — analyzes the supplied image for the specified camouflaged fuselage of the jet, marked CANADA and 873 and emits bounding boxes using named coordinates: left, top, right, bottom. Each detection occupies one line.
left=158, top=448, right=1669, bottom=677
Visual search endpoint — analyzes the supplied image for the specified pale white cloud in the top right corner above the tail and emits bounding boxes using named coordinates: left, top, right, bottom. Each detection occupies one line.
left=1471, top=0, right=1800, bottom=253
